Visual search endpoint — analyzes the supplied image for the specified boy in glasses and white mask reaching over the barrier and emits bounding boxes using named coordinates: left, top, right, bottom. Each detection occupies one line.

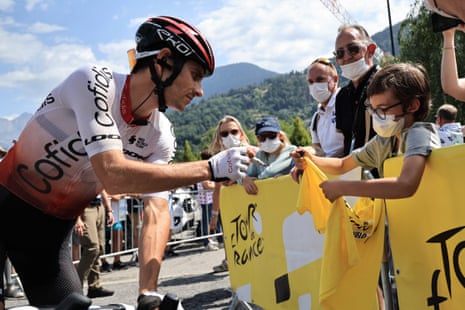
left=292, top=63, right=441, bottom=201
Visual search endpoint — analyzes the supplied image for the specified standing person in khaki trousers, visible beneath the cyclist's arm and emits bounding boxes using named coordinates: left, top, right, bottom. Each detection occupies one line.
left=75, top=195, right=114, bottom=298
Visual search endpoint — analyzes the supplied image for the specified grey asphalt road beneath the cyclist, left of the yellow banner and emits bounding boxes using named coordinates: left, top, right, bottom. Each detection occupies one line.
left=6, top=241, right=232, bottom=310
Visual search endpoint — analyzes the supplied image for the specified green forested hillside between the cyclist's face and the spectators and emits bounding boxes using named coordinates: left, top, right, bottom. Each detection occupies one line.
left=167, top=72, right=316, bottom=157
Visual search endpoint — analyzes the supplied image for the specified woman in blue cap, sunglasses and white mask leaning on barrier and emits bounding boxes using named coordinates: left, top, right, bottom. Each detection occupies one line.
left=242, top=117, right=297, bottom=195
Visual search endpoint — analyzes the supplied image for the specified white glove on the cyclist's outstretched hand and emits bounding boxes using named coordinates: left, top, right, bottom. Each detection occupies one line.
left=208, top=146, right=250, bottom=182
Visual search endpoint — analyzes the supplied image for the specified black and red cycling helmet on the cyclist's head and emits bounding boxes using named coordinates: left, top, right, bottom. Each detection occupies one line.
left=136, top=16, right=215, bottom=76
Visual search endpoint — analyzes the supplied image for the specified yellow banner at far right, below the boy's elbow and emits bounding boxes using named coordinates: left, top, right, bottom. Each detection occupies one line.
left=385, top=145, right=465, bottom=310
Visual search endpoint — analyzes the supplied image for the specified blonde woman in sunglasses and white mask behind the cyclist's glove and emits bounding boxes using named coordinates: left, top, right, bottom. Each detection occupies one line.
left=208, top=115, right=256, bottom=272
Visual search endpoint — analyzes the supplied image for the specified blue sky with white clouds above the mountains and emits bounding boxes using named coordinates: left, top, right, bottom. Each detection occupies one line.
left=0, top=0, right=415, bottom=118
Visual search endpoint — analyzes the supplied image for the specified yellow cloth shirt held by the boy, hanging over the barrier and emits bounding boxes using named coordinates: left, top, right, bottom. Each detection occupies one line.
left=297, top=159, right=384, bottom=310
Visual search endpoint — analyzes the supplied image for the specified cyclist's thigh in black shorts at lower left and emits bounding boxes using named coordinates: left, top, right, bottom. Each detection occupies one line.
left=0, top=189, right=82, bottom=306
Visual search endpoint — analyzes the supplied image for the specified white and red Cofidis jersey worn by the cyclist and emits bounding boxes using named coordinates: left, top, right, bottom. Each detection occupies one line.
left=0, top=65, right=175, bottom=219
